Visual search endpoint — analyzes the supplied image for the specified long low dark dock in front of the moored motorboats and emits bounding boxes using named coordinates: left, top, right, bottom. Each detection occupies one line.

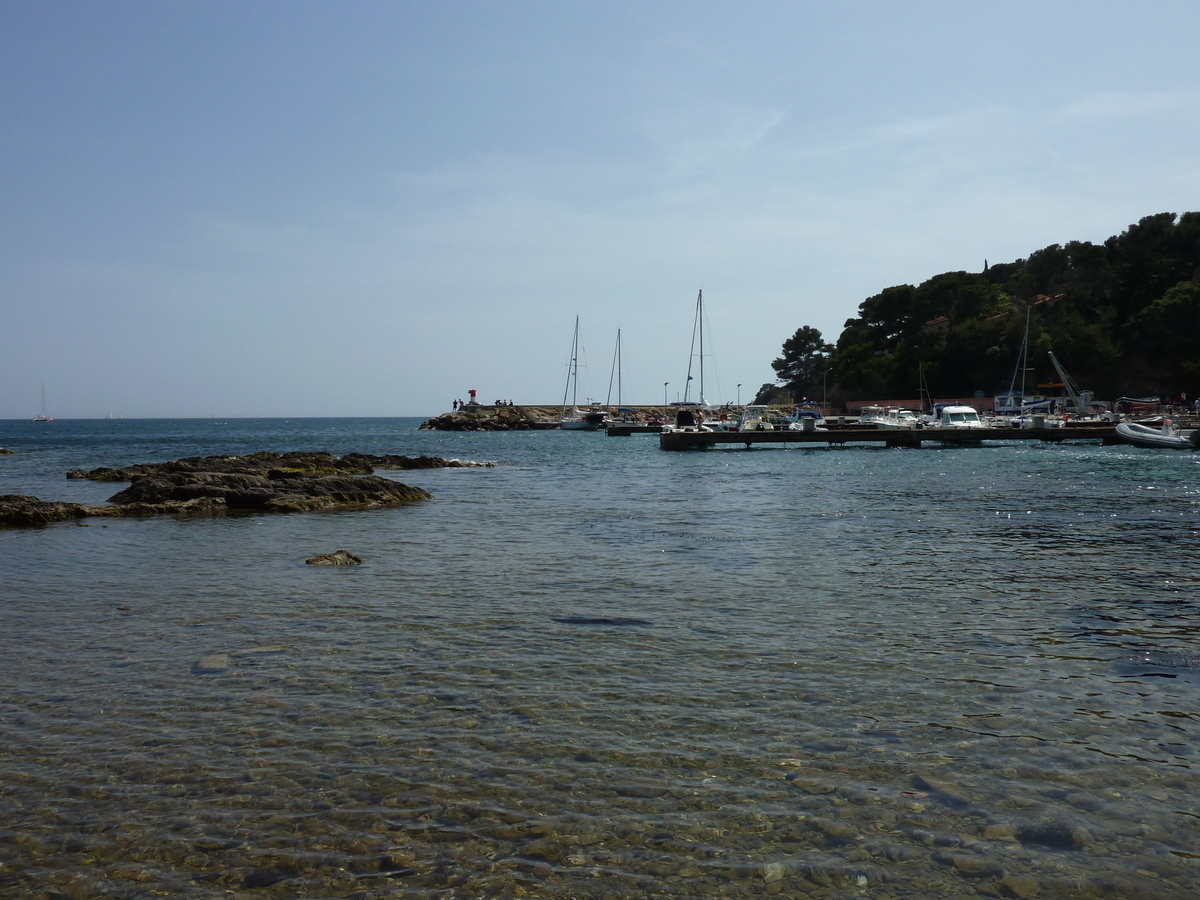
left=657, top=424, right=1120, bottom=450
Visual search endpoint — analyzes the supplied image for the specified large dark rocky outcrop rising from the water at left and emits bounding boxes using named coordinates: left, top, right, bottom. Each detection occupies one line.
left=0, top=451, right=493, bottom=528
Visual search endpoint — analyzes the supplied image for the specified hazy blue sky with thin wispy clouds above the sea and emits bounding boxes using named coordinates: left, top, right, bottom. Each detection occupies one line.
left=0, top=0, right=1200, bottom=419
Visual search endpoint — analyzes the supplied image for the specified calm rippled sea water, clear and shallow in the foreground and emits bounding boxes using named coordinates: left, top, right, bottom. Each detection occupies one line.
left=0, top=419, right=1200, bottom=900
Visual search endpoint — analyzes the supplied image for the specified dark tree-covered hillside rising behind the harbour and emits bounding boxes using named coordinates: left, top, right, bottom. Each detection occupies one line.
left=760, top=212, right=1200, bottom=401
